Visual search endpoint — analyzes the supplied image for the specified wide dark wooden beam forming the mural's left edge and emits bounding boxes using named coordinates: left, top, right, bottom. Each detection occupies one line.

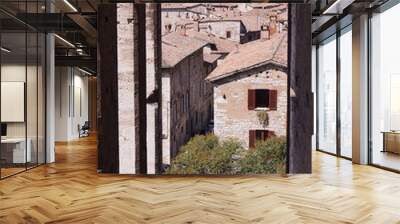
left=97, top=4, right=119, bottom=173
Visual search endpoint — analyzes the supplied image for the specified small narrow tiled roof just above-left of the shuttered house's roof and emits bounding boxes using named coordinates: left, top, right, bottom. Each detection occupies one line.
left=186, top=30, right=238, bottom=53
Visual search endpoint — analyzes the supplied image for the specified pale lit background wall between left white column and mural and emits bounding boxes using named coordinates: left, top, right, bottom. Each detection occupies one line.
left=55, top=67, right=89, bottom=141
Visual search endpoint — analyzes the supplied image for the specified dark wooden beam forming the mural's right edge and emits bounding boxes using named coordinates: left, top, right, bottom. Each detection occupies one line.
left=287, top=4, right=313, bottom=174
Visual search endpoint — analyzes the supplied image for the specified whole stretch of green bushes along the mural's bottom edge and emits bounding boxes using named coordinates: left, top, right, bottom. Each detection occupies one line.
left=166, top=134, right=286, bottom=175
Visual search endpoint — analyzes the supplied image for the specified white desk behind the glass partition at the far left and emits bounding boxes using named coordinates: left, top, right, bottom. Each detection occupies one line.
left=1, top=138, right=32, bottom=163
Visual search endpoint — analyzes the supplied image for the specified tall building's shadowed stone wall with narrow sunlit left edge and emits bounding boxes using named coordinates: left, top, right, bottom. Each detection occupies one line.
left=162, top=49, right=212, bottom=164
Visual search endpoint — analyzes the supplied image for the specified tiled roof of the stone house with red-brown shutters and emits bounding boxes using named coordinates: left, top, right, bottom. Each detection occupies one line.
left=207, top=32, right=287, bottom=81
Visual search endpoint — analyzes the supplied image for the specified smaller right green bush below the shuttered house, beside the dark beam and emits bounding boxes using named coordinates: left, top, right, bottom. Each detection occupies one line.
left=240, top=137, right=286, bottom=174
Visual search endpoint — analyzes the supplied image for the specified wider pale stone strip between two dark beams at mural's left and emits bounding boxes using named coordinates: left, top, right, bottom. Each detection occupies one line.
left=117, top=3, right=138, bottom=174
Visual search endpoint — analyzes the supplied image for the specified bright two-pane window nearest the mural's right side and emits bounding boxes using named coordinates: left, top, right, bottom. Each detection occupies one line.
left=315, top=25, right=352, bottom=159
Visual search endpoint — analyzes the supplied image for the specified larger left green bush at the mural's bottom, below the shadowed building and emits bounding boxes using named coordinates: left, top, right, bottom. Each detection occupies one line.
left=166, top=134, right=243, bottom=175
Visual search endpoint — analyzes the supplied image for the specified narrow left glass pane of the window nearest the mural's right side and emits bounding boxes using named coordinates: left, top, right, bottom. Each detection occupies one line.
left=318, top=36, right=336, bottom=153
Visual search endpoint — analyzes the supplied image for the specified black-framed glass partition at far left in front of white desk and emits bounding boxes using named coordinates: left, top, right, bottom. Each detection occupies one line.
left=0, top=1, right=46, bottom=178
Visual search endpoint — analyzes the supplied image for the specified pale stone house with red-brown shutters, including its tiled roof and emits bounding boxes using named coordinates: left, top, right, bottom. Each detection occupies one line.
left=207, top=33, right=287, bottom=148
